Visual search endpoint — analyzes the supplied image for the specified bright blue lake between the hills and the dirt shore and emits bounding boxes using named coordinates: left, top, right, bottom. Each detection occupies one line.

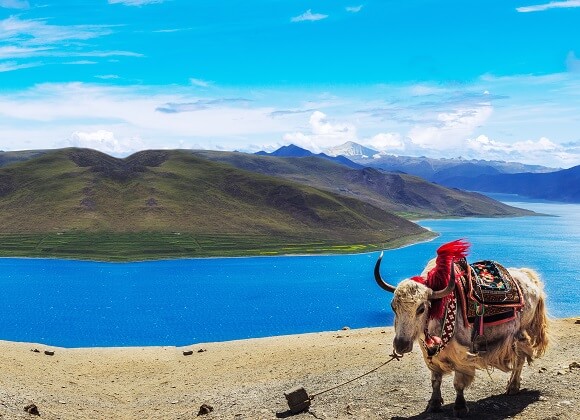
left=0, top=199, right=580, bottom=347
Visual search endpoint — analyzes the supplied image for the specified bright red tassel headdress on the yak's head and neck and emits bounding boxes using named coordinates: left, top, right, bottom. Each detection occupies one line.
left=413, top=239, right=470, bottom=319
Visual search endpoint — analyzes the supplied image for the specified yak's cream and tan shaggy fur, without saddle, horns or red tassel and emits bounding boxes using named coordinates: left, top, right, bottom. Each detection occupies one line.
left=377, top=240, right=548, bottom=416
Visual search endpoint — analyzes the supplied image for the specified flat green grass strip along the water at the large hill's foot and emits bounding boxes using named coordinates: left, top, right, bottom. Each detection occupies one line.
left=0, top=232, right=432, bottom=262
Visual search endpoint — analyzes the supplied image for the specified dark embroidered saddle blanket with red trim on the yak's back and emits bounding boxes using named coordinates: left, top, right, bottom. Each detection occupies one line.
left=455, top=259, right=524, bottom=325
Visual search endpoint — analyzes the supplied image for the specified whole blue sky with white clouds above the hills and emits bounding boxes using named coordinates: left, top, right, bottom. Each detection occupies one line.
left=0, top=0, right=580, bottom=167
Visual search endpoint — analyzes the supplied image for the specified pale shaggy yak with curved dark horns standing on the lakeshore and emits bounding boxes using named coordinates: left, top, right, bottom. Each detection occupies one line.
left=374, top=239, right=548, bottom=417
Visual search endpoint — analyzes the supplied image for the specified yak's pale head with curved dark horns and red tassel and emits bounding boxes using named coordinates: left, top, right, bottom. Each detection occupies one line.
left=375, top=240, right=469, bottom=355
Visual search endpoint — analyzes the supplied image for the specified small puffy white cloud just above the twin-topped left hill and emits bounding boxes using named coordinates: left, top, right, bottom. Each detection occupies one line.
left=64, top=130, right=145, bottom=156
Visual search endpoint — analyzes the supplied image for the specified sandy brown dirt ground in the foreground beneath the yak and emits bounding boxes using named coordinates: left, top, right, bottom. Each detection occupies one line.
left=0, top=318, right=580, bottom=420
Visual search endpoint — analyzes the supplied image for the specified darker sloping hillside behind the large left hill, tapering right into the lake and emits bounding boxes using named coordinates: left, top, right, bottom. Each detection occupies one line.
left=194, top=151, right=533, bottom=218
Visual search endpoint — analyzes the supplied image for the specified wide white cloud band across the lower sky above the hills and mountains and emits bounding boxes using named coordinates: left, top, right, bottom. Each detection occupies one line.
left=0, top=79, right=580, bottom=167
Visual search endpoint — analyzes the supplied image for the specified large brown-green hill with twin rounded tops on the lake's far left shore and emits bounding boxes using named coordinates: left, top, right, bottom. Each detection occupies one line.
left=0, top=149, right=430, bottom=260
